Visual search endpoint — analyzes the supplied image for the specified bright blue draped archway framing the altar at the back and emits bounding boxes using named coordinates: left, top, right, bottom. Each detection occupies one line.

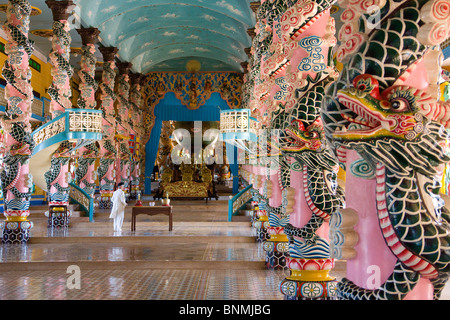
left=145, top=92, right=238, bottom=194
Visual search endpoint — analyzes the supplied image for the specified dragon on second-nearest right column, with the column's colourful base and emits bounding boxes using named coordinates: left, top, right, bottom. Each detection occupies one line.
left=280, top=77, right=344, bottom=299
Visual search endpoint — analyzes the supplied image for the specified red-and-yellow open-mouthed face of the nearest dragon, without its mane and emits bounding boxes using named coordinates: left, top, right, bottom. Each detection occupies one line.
left=333, top=74, right=428, bottom=141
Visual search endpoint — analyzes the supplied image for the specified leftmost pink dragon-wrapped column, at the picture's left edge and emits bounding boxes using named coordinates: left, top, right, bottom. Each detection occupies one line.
left=0, top=0, right=34, bottom=243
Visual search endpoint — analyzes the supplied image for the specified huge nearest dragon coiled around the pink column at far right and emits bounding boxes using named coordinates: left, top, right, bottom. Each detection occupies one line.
left=322, top=0, right=450, bottom=300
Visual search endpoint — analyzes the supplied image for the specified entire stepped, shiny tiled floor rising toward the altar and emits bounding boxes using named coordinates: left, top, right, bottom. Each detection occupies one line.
left=0, top=201, right=450, bottom=301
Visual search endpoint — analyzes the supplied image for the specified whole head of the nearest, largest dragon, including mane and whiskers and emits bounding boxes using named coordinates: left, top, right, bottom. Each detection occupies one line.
left=331, top=74, right=450, bottom=174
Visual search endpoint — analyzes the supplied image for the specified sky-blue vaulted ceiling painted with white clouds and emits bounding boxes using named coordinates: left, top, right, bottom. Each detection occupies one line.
left=74, top=0, right=255, bottom=73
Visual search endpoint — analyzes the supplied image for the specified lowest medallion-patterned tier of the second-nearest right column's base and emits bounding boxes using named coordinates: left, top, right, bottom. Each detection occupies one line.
left=280, top=278, right=337, bottom=300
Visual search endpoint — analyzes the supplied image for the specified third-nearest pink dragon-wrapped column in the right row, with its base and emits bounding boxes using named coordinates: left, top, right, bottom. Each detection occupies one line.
left=248, top=1, right=293, bottom=269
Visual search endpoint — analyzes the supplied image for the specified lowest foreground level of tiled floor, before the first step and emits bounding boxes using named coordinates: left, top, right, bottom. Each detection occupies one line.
left=0, top=270, right=284, bottom=300
